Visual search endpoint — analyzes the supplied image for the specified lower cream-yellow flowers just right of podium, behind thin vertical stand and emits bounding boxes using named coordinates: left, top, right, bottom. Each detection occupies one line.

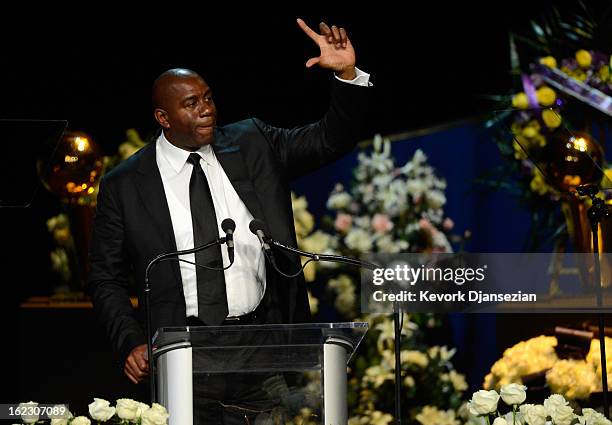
left=349, top=314, right=468, bottom=425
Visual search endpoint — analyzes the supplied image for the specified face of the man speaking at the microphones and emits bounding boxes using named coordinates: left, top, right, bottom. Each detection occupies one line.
left=155, top=76, right=217, bottom=151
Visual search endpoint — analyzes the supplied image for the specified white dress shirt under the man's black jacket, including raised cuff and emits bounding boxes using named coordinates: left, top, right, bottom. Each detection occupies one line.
left=155, top=69, right=371, bottom=317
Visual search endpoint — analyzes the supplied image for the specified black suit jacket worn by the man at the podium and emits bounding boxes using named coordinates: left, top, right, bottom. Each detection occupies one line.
left=88, top=79, right=372, bottom=364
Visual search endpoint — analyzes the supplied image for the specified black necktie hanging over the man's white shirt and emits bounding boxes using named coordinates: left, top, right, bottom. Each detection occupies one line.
left=187, top=153, right=228, bottom=325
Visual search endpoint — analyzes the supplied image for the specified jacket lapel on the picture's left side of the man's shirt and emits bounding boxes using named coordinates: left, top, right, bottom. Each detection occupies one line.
left=136, top=141, right=183, bottom=293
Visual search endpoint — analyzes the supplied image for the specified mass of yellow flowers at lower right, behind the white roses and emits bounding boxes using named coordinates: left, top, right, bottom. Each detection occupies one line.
left=483, top=336, right=612, bottom=400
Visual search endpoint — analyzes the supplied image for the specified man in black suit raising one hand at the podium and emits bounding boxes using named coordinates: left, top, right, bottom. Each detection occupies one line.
left=89, top=19, right=371, bottom=420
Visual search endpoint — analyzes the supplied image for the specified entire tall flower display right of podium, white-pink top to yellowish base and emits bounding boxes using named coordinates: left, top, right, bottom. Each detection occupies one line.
left=293, top=136, right=467, bottom=425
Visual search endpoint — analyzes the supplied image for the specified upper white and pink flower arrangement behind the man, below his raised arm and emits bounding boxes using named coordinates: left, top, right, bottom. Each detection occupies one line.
left=292, top=135, right=454, bottom=319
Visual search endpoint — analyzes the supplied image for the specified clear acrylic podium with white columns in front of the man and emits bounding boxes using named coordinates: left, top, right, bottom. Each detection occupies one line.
left=153, top=322, right=368, bottom=425
